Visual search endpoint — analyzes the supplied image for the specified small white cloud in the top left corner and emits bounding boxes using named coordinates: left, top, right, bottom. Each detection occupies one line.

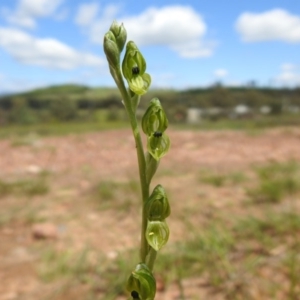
left=3, top=0, right=64, bottom=28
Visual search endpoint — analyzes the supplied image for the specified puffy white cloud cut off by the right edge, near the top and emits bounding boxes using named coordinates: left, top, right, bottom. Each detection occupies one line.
left=235, top=9, right=300, bottom=43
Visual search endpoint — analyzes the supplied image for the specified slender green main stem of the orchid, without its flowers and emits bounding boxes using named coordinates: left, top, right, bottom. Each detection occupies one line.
left=111, top=69, right=149, bottom=263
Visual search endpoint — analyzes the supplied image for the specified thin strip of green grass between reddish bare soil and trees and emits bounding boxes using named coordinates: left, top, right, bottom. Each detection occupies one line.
left=0, top=109, right=300, bottom=141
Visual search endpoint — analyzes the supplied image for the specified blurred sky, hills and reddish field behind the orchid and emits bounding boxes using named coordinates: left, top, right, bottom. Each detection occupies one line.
left=0, top=0, right=300, bottom=300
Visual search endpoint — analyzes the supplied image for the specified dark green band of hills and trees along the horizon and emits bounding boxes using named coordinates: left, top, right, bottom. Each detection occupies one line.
left=0, top=85, right=300, bottom=124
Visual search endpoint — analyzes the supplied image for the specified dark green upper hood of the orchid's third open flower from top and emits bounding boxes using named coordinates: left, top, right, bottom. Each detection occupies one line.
left=145, top=184, right=171, bottom=221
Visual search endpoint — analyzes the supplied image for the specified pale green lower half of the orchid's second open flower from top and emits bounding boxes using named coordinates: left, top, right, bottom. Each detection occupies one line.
left=147, top=132, right=171, bottom=161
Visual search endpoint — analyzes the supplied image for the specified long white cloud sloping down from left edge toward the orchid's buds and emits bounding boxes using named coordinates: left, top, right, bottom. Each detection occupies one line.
left=0, top=27, right=103, bottom=70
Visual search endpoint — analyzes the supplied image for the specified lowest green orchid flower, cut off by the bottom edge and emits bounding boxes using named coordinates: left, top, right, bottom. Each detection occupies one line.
left=127, top=263, right=156, bottom=300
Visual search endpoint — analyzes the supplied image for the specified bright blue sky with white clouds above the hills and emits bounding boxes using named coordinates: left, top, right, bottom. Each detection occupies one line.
left=0, top=0, right=300, bottom=94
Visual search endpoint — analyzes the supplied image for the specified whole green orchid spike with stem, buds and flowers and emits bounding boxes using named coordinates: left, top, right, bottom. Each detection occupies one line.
left=103, top=22, right=171, bottom=300
